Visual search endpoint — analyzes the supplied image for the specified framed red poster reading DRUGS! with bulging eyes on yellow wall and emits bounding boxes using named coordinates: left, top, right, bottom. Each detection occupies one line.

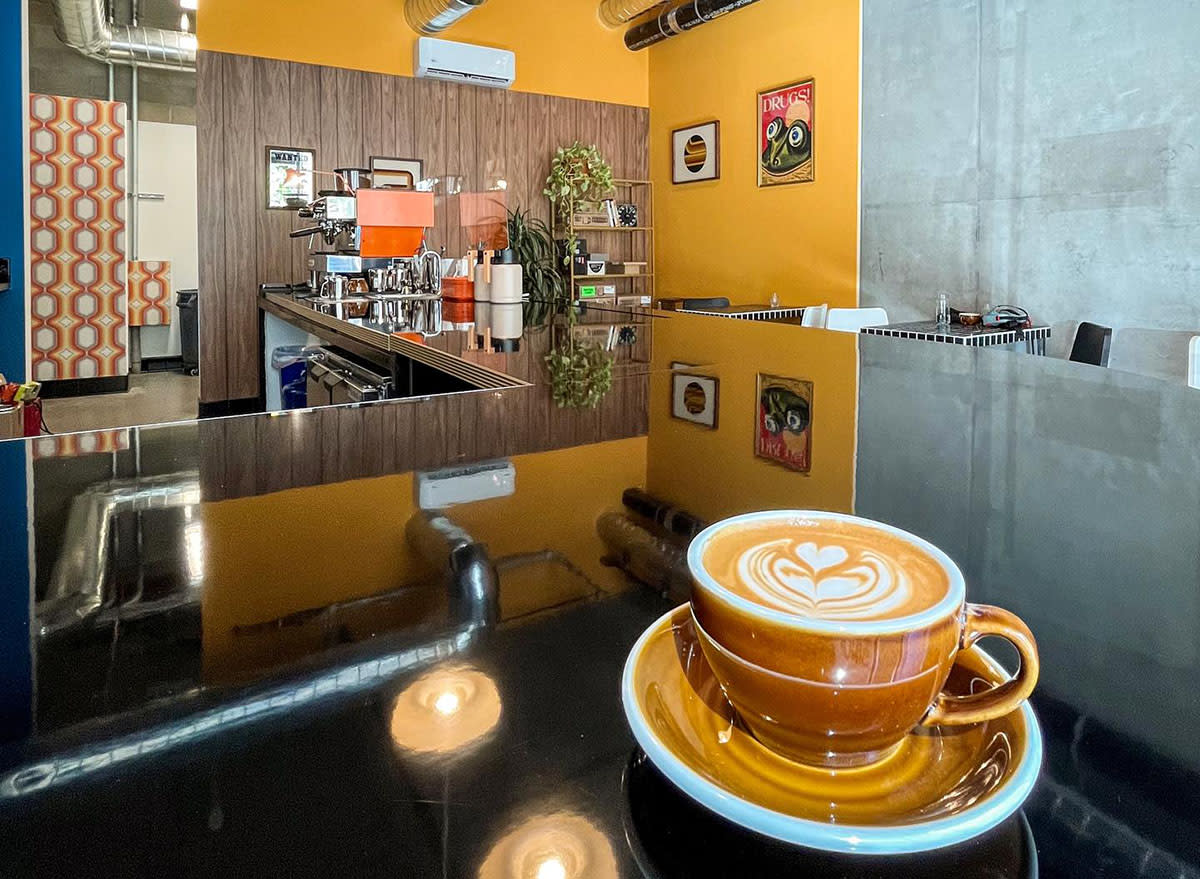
left=758, top=79, right=816, bottom=186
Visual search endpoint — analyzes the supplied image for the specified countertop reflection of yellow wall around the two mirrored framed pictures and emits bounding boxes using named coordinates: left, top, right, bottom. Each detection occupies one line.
left=647, top=315, right=858, bottom=519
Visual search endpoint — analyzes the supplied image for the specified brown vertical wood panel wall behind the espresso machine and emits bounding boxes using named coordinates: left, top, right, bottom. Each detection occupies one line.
left=197, top=52, right=649, bottom=408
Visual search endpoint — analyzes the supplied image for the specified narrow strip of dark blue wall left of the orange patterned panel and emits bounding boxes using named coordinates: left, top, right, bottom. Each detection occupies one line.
left=0, top=0, right=26, bottom=379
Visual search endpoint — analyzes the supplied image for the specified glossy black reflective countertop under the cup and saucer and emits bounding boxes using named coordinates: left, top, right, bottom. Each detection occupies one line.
left=0, top=326, right=1200, bottom=879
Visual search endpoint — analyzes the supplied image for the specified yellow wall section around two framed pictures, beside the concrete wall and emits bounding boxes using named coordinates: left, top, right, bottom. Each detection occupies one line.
left=650, top=0, right=859, bottom=306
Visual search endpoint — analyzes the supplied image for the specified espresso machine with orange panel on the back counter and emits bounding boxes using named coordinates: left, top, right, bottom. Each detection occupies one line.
left=290, top=168, right=442, bottom=336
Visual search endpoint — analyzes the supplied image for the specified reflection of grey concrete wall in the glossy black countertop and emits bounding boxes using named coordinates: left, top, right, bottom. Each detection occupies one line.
left=859, top=337, right=1200, bottom=768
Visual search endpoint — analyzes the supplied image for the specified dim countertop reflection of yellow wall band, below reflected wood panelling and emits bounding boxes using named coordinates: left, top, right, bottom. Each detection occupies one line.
left=200, top=437, right=647, bottom=681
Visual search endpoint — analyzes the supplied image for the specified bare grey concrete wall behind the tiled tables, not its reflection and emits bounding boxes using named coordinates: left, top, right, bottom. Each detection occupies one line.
left=862, top=0, right=1200, bottom=379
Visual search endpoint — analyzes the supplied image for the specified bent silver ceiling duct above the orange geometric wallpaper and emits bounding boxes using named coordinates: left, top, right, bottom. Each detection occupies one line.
left=54, top=0, right=196, bottom=71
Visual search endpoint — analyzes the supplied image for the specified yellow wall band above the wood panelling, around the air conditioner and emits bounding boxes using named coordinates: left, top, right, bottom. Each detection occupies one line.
left=196, top=0, right=648, bottom=107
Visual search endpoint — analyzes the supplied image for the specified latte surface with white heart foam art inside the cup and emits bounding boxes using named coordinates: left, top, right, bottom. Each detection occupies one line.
left=701, top=518, right=950, bottom=621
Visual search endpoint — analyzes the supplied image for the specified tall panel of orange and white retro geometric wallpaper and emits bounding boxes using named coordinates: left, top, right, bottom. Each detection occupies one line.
left=29, top=95, right=128, bottom=382
